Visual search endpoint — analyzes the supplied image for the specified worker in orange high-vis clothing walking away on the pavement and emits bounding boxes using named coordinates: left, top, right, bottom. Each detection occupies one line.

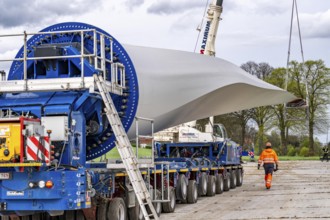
left=258, top=142, right=278, bottom=189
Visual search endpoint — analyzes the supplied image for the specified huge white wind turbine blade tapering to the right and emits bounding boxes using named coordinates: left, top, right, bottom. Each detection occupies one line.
left=125, top=45, right=295, bottom=137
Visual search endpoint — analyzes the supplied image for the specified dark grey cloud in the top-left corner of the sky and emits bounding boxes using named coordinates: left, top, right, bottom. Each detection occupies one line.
left=0, top=0, right=101, bottom=28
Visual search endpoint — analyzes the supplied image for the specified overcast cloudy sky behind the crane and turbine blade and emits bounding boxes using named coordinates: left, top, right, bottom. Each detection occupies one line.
left=0, top=0, right=330, bottom=141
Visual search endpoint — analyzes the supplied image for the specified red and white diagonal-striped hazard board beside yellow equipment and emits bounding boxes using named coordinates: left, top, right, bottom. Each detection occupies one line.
left=26, top=136, right=50, bottom=163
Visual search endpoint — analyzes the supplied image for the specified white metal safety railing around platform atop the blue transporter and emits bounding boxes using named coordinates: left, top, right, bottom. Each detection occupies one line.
left=0, top=29, right=126, bottom=95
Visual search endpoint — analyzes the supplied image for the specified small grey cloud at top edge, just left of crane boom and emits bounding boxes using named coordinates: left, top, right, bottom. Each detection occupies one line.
left=147, top=0, right=206, bottom=15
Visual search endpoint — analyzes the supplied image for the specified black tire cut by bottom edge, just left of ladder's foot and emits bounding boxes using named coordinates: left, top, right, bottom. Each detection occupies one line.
left=107, top=197, right=127, bottom=220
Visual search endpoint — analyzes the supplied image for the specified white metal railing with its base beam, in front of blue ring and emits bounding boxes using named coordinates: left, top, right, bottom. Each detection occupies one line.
left=0, top=29, right=126, bottom=95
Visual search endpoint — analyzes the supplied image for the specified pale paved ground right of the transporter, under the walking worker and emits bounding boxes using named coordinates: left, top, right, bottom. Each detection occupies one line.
left=160, top=161, right=330, bottom=220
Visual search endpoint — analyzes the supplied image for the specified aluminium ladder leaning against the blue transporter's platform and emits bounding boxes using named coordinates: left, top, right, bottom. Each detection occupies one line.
left=94, top=74, right=158, bottom=220
